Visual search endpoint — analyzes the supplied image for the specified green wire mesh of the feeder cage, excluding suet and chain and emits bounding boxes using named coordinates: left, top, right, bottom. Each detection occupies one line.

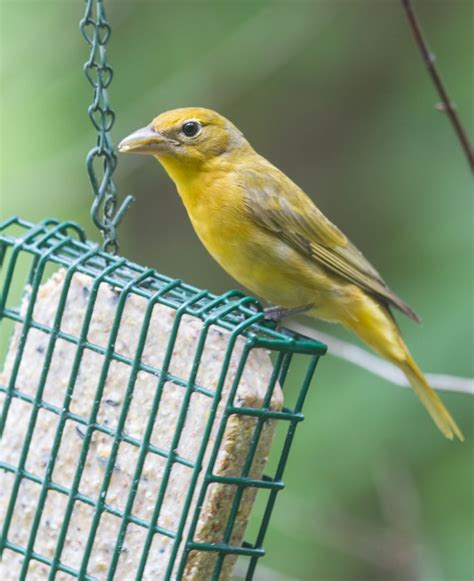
left=0, top=218, right=325, bottom=580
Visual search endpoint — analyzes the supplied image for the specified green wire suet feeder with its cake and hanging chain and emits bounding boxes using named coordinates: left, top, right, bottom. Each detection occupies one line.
left=0, top=0, right=326, bottom=581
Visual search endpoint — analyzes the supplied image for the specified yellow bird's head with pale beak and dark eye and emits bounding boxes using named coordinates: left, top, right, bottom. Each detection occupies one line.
left=118, top=107, right=248, bottom=168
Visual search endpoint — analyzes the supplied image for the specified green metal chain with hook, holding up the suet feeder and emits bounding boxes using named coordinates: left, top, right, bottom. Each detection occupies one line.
left=80, top=0, right=134, bottom=254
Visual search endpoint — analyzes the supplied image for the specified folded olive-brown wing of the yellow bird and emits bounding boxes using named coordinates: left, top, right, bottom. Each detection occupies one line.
left=241, top=166, right=420, bottom=322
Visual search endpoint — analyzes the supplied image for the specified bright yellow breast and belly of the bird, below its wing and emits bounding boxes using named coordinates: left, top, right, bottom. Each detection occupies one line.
left=172, top=175, right=338, bottom=307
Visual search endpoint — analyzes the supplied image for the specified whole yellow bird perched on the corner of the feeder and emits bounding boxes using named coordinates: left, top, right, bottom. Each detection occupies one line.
left=119, top=107, right=463, bottom=440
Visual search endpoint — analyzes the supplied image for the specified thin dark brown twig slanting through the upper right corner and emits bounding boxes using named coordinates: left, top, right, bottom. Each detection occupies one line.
left=401, top=0, right=474, bottom=171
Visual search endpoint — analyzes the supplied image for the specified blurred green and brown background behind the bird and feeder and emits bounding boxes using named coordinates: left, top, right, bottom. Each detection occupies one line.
left=0, top=0, right=474, bottom=581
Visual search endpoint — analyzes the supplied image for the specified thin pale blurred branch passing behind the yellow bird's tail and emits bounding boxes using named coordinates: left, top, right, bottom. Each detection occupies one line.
left=288, top=322, right=474, bottom=395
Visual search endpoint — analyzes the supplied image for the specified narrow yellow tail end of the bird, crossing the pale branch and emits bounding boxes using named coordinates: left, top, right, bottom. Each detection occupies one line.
left=399, top=355, right=464, bottom=442
